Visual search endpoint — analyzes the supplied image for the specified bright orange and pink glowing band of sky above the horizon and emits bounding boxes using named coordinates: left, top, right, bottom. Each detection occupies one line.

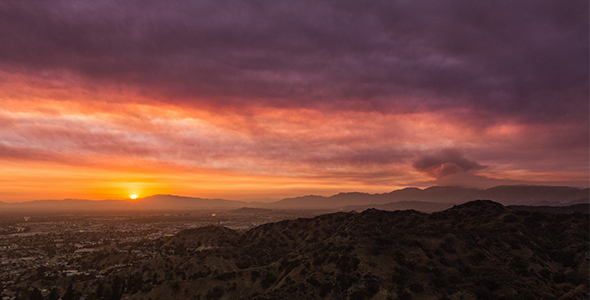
left=0, top=74, right=587, bottom=201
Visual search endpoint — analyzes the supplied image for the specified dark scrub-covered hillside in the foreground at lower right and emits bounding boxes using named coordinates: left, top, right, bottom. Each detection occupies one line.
left=108, top=201, right=589, bottom=300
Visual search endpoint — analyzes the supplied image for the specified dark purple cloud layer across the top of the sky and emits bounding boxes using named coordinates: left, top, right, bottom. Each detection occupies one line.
left=0, top=0, right=589, bottom=124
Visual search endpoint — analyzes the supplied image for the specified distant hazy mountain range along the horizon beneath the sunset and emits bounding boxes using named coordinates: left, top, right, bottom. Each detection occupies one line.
left=0, top=185, right=590, bottom=212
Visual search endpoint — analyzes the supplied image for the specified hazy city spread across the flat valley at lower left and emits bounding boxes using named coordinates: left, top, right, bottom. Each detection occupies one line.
left=0, top=208, right=328, bottom=300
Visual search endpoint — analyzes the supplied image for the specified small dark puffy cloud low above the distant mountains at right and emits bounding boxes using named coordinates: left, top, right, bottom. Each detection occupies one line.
left=413, top=149, right=486, bottom=178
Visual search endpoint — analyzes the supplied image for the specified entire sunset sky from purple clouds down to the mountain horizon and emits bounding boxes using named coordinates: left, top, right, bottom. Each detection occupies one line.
left=0, top=0, right=590, bottom=202
